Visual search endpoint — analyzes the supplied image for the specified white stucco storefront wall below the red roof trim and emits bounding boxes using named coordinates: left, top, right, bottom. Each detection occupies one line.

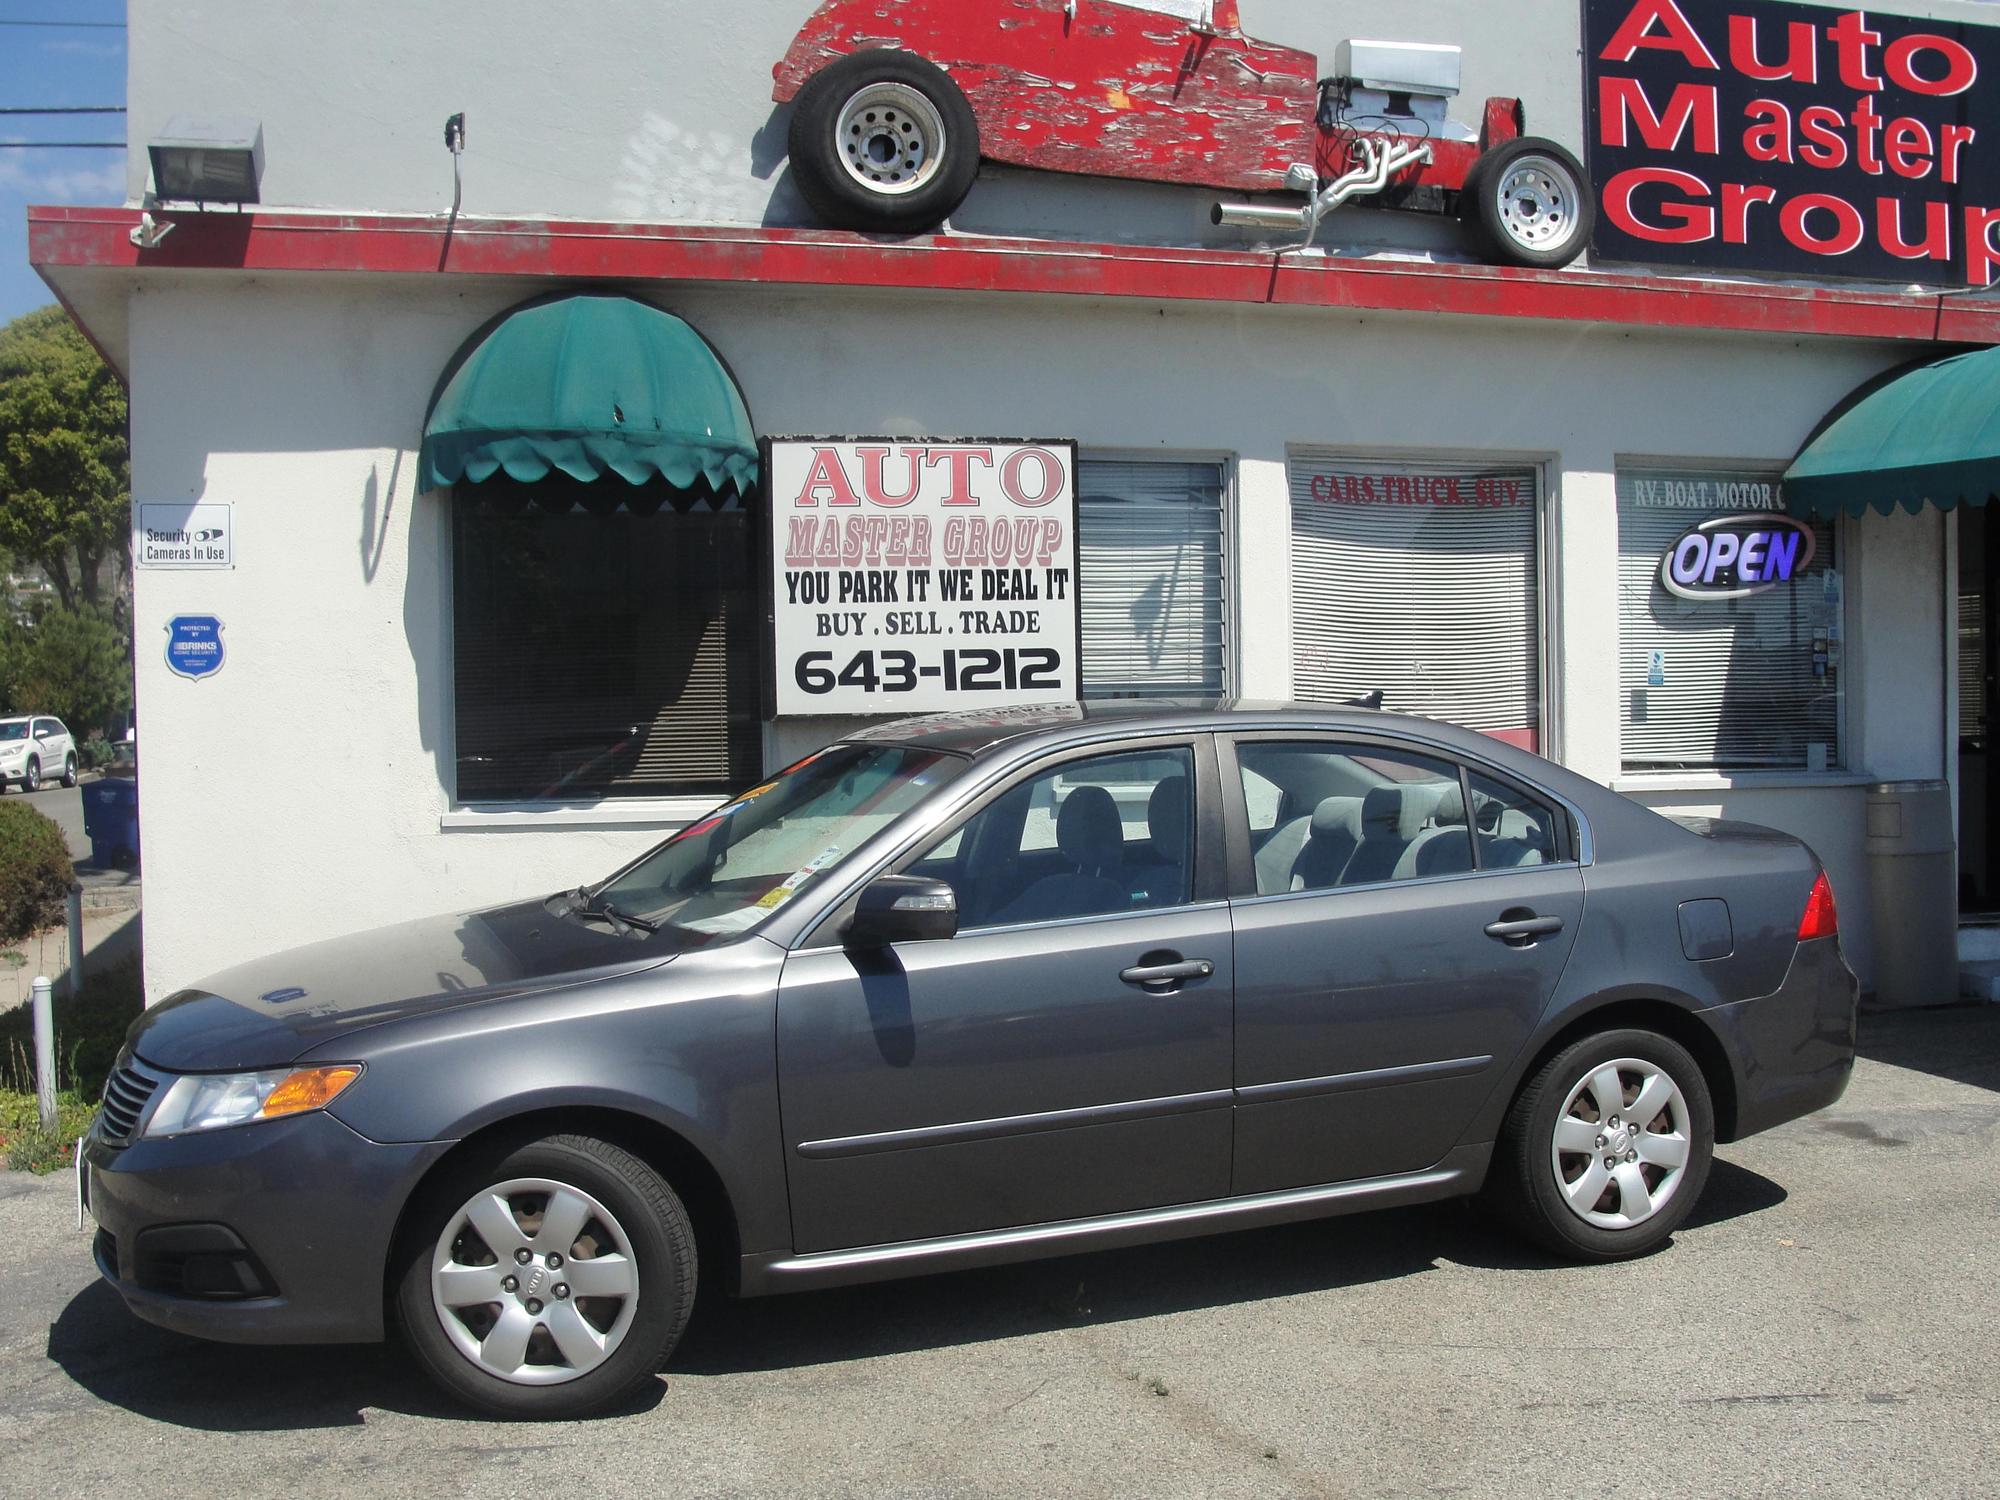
left=130, top=276, right=1920, bottom=998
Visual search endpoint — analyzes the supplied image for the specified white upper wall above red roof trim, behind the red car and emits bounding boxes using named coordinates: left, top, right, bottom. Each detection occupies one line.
left=126, top=0, right=1994, bottom=250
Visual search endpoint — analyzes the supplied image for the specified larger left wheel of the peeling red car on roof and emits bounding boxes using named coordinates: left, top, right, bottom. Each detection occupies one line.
left=788, top=48, right=980, bottom=234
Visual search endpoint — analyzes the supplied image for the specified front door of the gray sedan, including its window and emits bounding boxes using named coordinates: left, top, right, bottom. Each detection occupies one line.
left=778, top=738, right=1232, bottom=1252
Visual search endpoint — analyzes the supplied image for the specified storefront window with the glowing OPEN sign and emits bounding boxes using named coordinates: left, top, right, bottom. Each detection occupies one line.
left=1618, top=468, right=1842, bottom=772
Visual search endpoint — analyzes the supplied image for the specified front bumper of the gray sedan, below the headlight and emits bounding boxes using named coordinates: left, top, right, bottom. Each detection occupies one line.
left=80, top=1112, right=450, bottom=1344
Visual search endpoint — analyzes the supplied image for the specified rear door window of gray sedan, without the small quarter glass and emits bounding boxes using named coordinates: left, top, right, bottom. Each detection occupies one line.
left=1236, top=742, right=1472, bottom=896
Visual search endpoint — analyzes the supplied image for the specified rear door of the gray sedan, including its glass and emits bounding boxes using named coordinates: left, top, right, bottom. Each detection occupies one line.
left=1222, top=734, right=1584, bottom=1192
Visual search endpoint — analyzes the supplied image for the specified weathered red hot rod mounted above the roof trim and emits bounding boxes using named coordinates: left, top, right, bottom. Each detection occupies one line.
left=772, top=0, right=1590, bottom=266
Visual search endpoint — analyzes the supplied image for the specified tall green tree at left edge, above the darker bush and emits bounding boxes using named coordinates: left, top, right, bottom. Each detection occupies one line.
left=0, top=306, right=132, bottom=610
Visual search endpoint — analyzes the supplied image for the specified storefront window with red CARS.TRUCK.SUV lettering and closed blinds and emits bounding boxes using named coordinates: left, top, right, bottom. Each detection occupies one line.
left=1292, top=452, right=1542, bottom=750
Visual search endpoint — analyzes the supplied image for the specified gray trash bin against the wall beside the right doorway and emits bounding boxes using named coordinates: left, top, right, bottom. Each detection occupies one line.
left=1868, top=782, right=1958, bottom=1010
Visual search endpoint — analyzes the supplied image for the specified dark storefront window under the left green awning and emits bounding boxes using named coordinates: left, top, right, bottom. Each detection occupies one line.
left=452, top=480, right=760, bottom=802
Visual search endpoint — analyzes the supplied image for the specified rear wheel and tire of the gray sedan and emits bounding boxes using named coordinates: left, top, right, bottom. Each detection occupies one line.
left=1486, top=1030, right=1716, bottom=1260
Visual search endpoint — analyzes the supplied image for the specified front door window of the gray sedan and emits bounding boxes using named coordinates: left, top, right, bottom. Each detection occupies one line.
left=906, top=748, right=1194, bottom=930
